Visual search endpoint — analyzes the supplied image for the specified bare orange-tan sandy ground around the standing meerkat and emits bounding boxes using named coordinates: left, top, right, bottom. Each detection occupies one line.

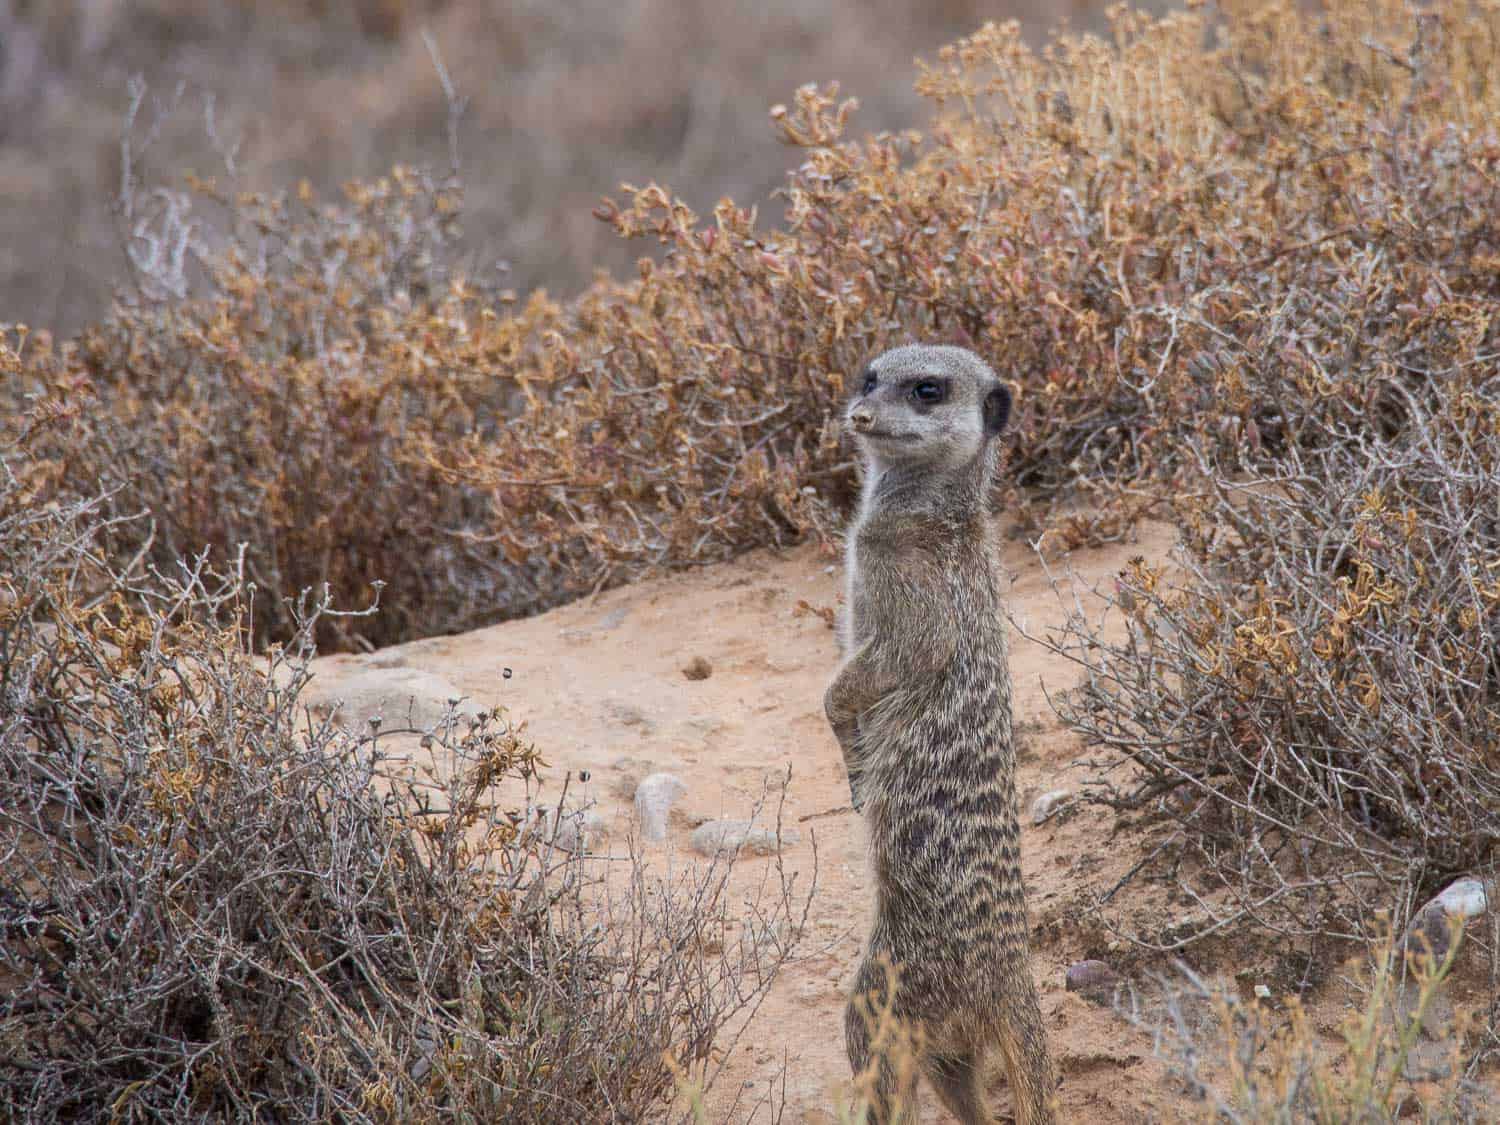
left=298, top=527, right=1494, bottom=1125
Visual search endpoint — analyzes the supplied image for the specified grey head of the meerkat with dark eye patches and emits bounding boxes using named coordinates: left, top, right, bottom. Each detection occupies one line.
left=845, top=344, right=1011, bottom=471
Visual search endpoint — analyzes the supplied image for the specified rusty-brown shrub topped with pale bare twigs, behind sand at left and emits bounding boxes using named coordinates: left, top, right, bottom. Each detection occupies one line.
left=12, top=160, right=570, bottom=648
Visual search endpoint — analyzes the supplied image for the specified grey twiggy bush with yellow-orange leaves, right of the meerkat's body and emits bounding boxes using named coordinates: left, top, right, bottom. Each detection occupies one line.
left=1044, top=365, right=1500, bottom=941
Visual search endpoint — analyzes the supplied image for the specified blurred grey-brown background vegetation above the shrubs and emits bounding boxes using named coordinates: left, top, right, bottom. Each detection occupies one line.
left=0, top=0, right=1128, bottom=335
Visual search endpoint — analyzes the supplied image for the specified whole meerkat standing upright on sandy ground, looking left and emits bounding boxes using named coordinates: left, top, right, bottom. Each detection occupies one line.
left=824, top=345, right=1056, bottom=1125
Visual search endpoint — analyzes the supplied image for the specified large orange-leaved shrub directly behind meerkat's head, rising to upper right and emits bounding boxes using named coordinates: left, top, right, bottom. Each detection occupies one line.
left=435, top=5, right=1500, bottom=609
